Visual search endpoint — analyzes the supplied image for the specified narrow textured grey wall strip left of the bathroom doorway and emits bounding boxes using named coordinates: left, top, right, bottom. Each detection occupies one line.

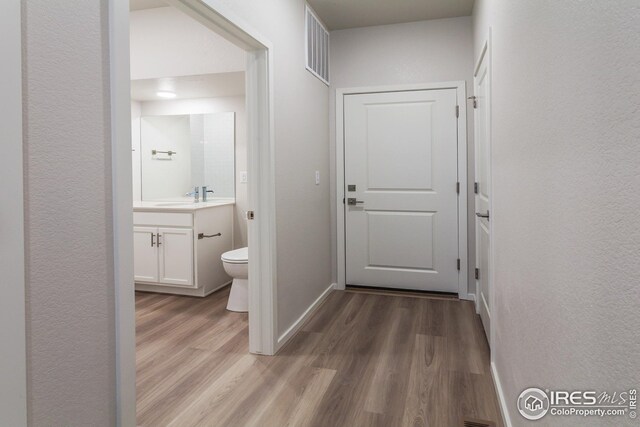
left=23, top=0, right=115, bottom=426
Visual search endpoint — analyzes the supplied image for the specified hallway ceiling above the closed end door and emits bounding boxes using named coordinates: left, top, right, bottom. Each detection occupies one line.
left=304, top=0, right=474, bottom=30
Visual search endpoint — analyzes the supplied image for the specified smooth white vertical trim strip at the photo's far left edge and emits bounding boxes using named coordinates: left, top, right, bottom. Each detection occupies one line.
left=0, top=0, right=27, bottom=427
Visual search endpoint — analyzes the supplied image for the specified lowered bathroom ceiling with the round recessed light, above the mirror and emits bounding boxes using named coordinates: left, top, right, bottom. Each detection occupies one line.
left=131, top=71, right=244, bottom=101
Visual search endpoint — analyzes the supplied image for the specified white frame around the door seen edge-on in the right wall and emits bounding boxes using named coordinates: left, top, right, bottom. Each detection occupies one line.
left=473, top=36, right=497, bottom=352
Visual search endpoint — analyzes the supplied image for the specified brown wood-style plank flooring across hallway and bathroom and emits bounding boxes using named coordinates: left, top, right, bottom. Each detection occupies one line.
left=136, top=288, right=503, bottom=427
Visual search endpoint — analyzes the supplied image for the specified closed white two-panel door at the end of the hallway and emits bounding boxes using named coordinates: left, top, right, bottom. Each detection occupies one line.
left=344, top=89, right=459, bottom=293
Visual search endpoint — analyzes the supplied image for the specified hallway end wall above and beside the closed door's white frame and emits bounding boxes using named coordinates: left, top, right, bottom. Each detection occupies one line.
left=329, top=17, right=475, bottom=292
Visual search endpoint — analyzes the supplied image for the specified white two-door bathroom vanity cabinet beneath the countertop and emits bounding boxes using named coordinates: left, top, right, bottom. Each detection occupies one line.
left=133, top=205, right=233, bottom=296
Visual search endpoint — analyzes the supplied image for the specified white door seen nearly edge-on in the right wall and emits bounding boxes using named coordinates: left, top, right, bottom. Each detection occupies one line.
left=474, top=46, right=492, bottom=341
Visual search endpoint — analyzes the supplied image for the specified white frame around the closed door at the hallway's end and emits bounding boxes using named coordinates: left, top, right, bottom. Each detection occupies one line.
left=336, top=81, right=473, bottom=299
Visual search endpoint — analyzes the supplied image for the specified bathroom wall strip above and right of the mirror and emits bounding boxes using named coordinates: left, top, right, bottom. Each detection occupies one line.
left=141, top=96, right=249, bottom=247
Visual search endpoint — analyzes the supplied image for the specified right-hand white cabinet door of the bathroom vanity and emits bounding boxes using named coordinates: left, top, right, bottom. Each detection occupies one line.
left=158, top=228, right=193, bottom=287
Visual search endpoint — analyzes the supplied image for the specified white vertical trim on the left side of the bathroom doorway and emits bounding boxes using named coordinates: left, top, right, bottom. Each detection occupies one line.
left=109, top=0, right=136, bottom=426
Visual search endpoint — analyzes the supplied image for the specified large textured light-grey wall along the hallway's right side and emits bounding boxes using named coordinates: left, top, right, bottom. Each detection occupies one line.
left=474, top=0, right=640, bottom=426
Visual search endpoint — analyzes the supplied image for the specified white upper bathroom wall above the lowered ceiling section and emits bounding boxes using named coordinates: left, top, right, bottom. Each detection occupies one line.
left=130, top=7, right=246, bottom=80
